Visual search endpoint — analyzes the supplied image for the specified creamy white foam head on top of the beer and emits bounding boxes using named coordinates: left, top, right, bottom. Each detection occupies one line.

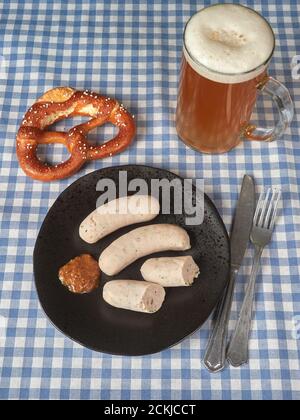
left=184, top=4, right=274, bottom=83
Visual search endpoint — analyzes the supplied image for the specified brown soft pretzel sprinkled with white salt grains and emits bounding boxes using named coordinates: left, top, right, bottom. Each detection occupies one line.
left=17, top=87, right=135, bottom=181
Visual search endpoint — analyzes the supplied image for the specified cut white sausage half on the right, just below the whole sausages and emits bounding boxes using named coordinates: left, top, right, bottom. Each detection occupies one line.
left=141, top=256, right=200, bottom=287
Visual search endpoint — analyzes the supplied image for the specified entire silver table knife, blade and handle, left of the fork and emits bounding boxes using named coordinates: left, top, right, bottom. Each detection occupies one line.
left=204, top=175, right=255, bottom=372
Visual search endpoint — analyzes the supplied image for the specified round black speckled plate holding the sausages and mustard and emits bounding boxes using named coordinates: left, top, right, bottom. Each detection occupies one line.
left=34, top=165, right=230, bottom=355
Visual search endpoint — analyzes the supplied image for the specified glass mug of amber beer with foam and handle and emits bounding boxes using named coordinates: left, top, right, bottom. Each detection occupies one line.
left=176, top=4, right=293, bottom=153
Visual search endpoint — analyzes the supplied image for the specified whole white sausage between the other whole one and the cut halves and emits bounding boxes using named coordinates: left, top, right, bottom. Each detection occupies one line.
left=99, top=224, right=191, bottom=276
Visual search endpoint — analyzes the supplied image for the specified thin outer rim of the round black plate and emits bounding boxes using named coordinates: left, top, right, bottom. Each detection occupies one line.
left=33, top=164, right=231, bottom=357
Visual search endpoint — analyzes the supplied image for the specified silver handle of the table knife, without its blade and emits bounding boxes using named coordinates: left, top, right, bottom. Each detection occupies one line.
left=204, top=269, right=238, bottom=373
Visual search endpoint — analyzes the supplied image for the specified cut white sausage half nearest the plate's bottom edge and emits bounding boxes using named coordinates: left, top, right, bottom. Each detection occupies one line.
left=103, top=280, right=165, bottom=313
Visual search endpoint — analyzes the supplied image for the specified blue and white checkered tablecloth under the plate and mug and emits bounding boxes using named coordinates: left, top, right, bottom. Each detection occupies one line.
left=0, top=0, right=300, bottom=399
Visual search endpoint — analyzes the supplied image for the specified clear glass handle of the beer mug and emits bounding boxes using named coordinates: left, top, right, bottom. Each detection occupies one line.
left=244, top=76, right=294, bottom=142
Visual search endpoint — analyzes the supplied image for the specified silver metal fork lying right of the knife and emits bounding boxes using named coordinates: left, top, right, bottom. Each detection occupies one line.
left=227, top=188, right=281, bottom=367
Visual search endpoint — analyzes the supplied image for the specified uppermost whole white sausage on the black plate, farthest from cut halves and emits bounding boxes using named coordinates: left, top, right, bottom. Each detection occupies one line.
left=79, top=195, right=160, bottom=244
